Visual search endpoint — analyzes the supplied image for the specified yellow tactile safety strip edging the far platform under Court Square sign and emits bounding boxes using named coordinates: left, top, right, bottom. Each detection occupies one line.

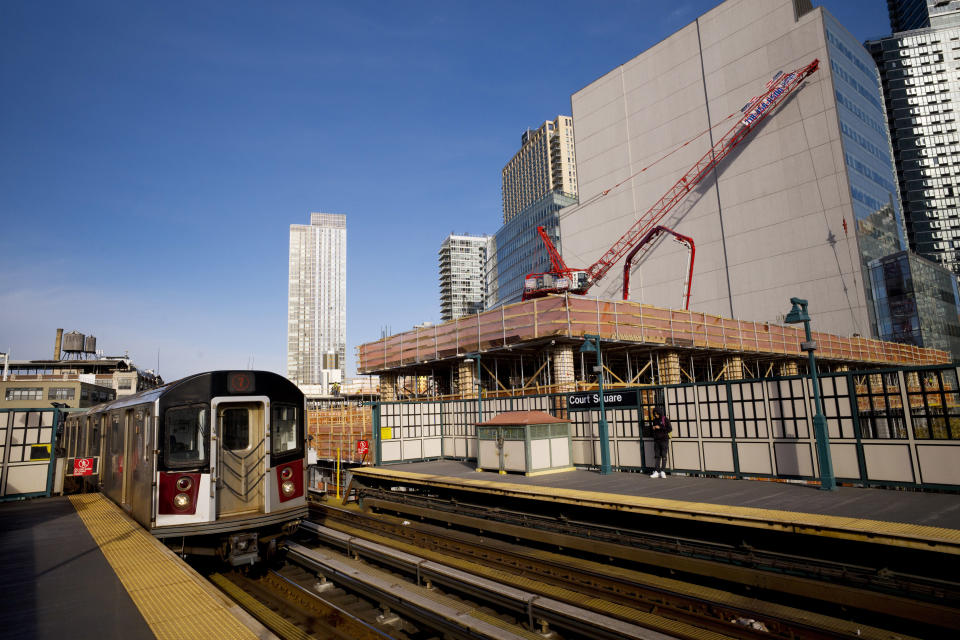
left=353, top=467, right=960, bottom=555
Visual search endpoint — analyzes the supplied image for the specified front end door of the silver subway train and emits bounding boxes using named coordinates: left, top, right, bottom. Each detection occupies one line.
left=217, top=402, right=265, bottom=517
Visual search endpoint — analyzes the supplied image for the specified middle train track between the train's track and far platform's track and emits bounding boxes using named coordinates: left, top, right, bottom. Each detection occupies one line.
left=312, top=495, right=960, bottom=638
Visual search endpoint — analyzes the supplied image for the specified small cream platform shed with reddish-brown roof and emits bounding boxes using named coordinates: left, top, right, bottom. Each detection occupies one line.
left=477, top=411, right=574, bottom=475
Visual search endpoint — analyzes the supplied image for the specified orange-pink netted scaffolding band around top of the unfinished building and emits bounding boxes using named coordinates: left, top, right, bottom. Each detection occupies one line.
left=357, top=295, right=951, bottom=374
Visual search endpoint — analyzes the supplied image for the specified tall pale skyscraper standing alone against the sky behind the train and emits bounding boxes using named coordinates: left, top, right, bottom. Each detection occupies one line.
left=287, top=213, right=347, bottom=385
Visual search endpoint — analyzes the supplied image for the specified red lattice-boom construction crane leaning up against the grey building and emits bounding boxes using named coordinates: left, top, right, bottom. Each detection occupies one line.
left=523, top=60, right=820, bottom=300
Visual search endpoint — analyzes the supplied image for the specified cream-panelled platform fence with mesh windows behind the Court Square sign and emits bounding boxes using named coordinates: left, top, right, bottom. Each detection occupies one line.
left=375, top=365, right=960, bottom=490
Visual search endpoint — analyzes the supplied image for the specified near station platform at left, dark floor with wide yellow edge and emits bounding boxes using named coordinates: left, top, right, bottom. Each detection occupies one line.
left=0, top=493, right=274, bottom=640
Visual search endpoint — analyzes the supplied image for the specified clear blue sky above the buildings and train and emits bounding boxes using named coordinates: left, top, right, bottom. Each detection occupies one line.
left=0, top=0, right=889, bottom=380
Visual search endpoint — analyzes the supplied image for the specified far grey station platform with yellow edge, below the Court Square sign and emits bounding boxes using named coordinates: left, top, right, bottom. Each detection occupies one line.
left=351, top=460, right=960, bottom=555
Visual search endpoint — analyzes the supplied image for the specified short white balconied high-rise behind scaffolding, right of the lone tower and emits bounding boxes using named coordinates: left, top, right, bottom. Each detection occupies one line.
left=437, top=233, right=490, bottom=322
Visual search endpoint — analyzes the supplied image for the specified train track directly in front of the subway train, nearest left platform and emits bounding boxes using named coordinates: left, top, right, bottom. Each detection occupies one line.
left=211, top=530, right=680, bottom=640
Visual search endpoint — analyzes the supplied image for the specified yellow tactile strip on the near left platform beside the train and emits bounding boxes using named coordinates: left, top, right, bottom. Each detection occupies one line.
left=70, top=493, right=258, bottom=640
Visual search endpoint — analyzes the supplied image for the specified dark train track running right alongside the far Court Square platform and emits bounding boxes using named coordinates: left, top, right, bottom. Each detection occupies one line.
left=348, top=489, right=960, bottom=628
